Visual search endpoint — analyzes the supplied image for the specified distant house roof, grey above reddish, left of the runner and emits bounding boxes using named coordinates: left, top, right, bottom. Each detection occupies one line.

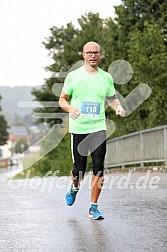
left=8, top=126, right=29, bottom=141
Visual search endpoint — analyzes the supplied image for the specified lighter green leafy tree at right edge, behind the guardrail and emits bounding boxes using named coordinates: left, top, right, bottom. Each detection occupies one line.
left=128, top=22, right=167, bottom=128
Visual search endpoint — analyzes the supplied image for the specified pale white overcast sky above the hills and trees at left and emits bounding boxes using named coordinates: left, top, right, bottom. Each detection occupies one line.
left=0, top=0, right=120, bottom=86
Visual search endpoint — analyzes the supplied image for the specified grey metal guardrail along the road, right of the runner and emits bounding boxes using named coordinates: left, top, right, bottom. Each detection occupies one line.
left=104, top=125, right=167, bottom=168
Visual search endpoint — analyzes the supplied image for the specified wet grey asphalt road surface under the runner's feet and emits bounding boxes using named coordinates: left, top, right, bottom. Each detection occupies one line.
left=0, top=172, right=167, bottom=252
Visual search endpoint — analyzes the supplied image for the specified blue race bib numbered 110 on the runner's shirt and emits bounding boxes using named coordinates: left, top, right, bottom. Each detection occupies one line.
left=81, top=101, right=100, bottom=116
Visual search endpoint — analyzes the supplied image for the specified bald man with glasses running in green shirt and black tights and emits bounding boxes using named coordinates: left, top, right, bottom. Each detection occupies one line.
left=59, top=41, right=125, bottom=220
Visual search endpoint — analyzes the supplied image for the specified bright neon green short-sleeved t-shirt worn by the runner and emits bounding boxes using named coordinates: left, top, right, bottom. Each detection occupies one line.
left=63, top=66, right=115, bottom=134
